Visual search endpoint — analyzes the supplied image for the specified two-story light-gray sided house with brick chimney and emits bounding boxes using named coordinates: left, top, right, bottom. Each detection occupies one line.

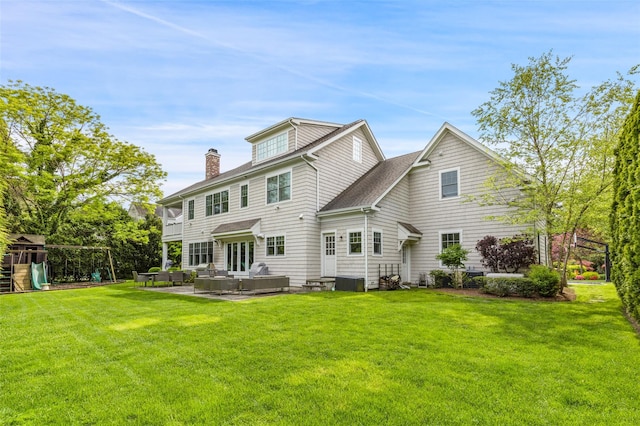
left=159, top=118, right=544, bottom=288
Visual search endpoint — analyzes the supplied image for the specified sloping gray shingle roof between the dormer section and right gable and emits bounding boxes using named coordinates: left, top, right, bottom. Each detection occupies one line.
left=320, top=151, right=421, bottom=212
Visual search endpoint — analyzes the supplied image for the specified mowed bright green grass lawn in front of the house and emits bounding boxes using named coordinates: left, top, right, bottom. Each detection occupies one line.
left=0, top=282, right=640, bottom=425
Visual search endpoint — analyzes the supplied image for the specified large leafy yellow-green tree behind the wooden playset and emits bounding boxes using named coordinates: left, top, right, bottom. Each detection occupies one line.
left=0, top=81, right=166, bottom=242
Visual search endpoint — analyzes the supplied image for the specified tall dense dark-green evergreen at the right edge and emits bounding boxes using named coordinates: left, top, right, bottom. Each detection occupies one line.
left=610, top=91, right=640, bottom=320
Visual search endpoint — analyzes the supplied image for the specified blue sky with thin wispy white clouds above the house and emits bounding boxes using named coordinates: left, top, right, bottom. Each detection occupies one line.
left=0, top=0, right=640, bottom=195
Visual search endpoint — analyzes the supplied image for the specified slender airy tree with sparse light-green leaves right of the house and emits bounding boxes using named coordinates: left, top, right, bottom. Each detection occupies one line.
left=472, top=51, right=636, bottom=283
